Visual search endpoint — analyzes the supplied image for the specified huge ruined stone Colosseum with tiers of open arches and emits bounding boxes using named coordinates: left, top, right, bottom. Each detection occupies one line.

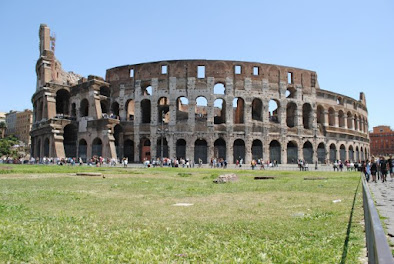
left=31, top=24, right=369, bottom=163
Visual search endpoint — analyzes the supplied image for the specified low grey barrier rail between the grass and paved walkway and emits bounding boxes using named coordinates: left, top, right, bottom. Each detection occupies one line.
left=362, top=177, right=394, bottom=264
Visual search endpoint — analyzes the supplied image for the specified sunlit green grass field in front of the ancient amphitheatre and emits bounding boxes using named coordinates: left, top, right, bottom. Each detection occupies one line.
left=0, top=165, right=364, bottom=263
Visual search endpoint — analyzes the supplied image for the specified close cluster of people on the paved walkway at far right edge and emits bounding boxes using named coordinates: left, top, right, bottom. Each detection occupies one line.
left=361, top=155, right=394, bottom=183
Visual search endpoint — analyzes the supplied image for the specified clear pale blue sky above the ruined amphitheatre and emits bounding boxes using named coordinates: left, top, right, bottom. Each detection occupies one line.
left=0, top=0, right=394, bottom=129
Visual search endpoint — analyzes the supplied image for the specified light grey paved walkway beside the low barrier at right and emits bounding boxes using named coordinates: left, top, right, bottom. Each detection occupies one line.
left=368, top=176, right=394, bottom=248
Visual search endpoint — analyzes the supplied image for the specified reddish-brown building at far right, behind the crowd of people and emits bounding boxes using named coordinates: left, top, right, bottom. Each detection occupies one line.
left=369, top=126, right=394, bottom=156
